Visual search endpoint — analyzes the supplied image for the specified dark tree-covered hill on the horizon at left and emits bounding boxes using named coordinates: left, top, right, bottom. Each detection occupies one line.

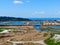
left=0, top=17, right=30, bottom=21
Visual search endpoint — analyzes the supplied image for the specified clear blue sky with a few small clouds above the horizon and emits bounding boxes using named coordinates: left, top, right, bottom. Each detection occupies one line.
left=0, top=0, right=60, bottom=18
